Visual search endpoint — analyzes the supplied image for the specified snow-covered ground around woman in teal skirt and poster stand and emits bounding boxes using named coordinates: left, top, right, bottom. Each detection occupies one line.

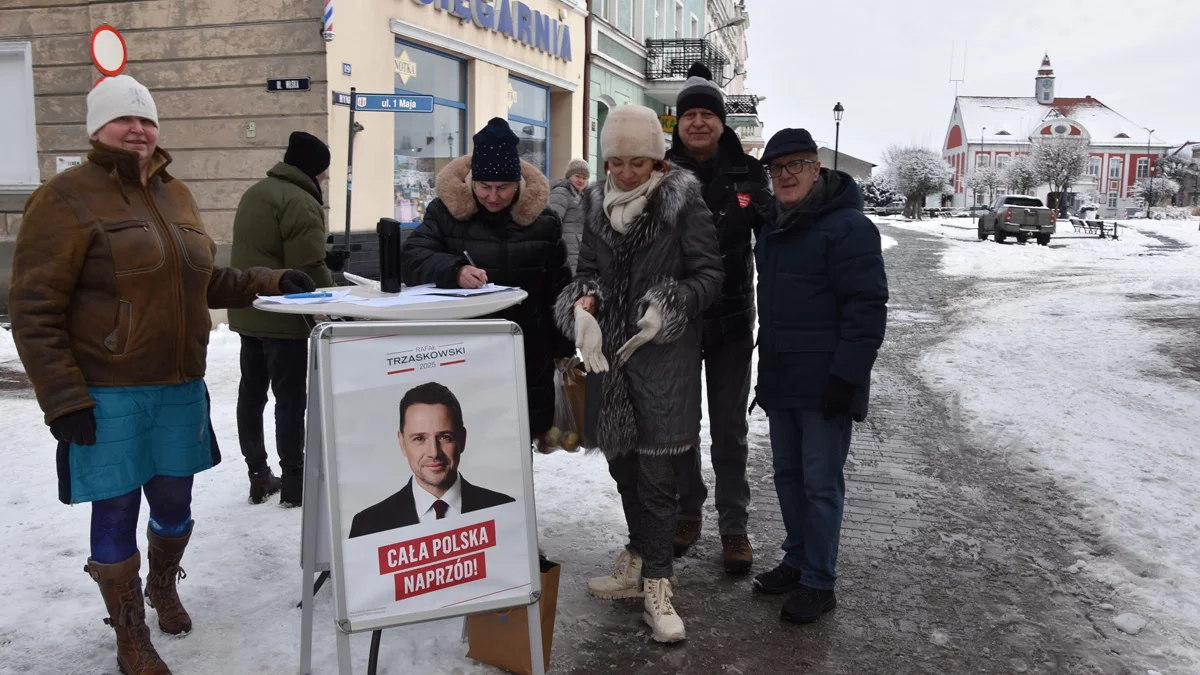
left=0, top=327, right=648, bottom=675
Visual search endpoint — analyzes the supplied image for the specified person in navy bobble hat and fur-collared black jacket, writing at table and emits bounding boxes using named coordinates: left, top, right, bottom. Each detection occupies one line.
left=401, top=118, right=575, bottom=446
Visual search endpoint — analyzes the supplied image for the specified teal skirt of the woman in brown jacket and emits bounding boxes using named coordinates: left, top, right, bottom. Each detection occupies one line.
left=58, top=380, right=221, bottom=504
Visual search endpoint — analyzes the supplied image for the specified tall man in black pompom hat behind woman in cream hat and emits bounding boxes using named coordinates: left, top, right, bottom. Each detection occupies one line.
left=667, top=64, right=770, bottom=573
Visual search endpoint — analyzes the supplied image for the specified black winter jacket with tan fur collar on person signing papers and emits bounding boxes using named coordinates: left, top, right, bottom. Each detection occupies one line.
left=401, top=155, right=575, bottom=435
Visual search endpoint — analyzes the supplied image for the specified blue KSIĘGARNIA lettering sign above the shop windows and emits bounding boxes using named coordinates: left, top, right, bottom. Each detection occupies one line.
left=413, top=0, right=571, bottom=62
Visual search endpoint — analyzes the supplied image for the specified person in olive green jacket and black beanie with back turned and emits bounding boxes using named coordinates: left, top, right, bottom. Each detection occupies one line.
left=229, top=131, right=344, bottom=507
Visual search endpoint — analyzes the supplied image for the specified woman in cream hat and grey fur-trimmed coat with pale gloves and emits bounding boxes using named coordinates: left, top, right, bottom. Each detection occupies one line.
left=554, top=106, right=724, bottom=643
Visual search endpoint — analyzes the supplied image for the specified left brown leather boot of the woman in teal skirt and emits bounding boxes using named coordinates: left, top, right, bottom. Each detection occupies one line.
left=83, top=554, right=170, bottom=675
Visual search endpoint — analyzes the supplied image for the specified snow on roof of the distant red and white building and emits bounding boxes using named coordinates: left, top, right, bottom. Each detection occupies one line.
left=958, top=96, right=1164, bottom=145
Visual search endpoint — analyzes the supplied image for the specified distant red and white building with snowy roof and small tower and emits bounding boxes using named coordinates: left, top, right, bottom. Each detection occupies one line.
left=942, top=55, right=1170, bottom=217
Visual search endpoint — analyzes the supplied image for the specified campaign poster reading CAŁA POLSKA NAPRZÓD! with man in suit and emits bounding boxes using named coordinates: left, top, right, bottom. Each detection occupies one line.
left=325, top=333, right=535, bottom=623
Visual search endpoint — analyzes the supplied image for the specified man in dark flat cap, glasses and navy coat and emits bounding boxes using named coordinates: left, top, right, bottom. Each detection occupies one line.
left=754, top=129, right=888, bottom=623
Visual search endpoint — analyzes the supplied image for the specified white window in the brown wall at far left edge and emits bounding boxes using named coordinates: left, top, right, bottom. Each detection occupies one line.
left=0, top=42, right=41, bottom=190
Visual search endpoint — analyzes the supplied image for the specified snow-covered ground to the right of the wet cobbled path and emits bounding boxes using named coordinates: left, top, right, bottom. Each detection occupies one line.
left=881, top=219, right=1200, bottom=673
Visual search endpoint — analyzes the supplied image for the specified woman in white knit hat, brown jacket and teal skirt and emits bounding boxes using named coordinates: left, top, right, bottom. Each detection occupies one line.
left=8, top=76, right=313, bottom=675
